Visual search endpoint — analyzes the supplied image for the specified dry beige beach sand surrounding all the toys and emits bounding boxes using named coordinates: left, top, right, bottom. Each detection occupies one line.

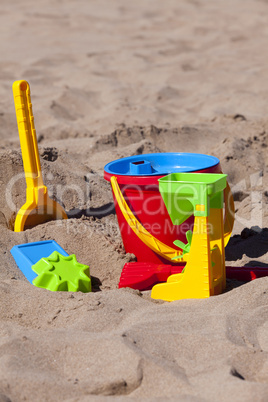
left=0, top=0, right=268, bottom=402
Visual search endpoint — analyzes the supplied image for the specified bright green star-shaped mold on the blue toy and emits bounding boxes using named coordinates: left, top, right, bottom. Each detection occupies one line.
left=32, top=251, right=91, bottom=293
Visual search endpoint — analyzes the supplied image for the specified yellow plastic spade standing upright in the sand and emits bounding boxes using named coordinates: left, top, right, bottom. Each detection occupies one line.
left=12, top=80, right=67, bottom=232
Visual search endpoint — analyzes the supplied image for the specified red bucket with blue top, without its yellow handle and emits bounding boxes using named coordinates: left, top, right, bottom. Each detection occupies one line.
left=104, top=153, right=221, bottom=265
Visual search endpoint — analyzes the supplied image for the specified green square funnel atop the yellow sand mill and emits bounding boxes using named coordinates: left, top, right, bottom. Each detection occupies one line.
left=158, top=173, right=227, bottom=225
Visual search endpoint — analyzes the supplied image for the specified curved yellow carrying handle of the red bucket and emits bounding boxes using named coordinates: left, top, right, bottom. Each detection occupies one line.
left=111, top=176, right=234, bottom=262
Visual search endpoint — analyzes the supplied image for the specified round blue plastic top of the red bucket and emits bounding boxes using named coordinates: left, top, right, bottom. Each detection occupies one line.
left=104, top=152, right=220, bottom=176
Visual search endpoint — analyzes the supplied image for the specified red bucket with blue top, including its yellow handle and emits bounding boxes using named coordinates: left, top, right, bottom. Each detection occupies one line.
left=104, top=153, right=234, bottom=287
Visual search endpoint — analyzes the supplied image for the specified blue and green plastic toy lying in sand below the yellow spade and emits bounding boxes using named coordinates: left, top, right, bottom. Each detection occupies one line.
left=11, top=240, right=91, bottom=292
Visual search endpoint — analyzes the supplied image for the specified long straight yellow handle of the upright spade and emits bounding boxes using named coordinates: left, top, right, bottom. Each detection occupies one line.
left=12, top=80, right=44, bottom=188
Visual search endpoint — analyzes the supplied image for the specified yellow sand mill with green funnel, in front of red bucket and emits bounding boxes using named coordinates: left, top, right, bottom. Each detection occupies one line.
left=151, top=173, right=226, bottom=301
